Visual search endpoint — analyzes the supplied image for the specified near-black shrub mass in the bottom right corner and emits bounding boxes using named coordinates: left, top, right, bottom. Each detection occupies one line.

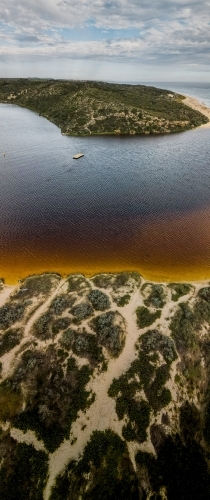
left=136, top=401, right=210, bottom=500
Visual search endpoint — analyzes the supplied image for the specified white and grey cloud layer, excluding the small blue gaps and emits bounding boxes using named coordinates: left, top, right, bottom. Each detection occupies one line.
left=0, top=0, right=210, bottom=77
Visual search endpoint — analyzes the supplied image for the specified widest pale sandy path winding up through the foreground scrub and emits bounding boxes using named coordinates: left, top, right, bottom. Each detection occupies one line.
left=44, top=282, right=177, bottom=500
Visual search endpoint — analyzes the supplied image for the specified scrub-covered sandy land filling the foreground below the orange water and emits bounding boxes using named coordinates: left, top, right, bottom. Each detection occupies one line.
left=0, top=271, right=210, bottom=500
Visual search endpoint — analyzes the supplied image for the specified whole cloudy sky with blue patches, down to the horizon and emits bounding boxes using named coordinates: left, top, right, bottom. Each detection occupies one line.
left=0, top=0, right=210, bottom=82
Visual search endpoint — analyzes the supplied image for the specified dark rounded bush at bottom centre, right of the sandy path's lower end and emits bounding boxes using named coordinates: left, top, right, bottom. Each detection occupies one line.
left=50, top=430, right=139, bottom=500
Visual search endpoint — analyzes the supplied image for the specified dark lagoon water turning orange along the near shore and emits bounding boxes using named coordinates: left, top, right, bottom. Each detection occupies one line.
left=0, top=84, right=210, bottom=283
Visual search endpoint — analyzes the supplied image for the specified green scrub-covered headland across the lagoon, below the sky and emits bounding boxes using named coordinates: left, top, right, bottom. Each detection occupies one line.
left=0, top=79, right=208, bottom=135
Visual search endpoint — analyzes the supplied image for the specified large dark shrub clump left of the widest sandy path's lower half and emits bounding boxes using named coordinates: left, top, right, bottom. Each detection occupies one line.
left=11, top=346, right=92, bottom=451
